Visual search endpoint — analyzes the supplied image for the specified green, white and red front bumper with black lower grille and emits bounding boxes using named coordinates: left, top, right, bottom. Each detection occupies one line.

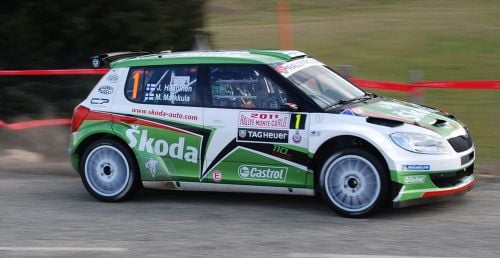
left=392, top=164, right=475, bottom=208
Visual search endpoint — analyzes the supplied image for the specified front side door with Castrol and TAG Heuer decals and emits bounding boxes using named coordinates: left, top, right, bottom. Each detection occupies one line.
left=201, top=65, right=309, bottom=187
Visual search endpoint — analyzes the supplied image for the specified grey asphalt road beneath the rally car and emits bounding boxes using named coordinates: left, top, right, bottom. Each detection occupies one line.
left=0, top=167, right=500, bottom=258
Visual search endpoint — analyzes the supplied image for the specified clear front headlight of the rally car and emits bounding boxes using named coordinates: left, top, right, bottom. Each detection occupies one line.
left=391, top=133, right=449, bottom=154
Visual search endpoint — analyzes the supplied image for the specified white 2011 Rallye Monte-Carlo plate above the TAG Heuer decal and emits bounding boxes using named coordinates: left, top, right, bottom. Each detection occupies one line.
left=238, top=111, right=290, bottom=129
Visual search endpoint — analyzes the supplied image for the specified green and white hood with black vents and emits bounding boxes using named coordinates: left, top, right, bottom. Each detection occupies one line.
left=341, top=98, right=463, bottom=137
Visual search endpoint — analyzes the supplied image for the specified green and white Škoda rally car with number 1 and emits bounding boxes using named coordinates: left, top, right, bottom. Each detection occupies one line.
left=69, top=50, right=475, bottom=217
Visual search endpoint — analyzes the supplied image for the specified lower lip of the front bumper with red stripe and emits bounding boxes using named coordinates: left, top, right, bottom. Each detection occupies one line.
left=393, top=175, right=475, bottom=208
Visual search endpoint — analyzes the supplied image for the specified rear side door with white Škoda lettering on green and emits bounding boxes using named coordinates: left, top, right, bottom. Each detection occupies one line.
left=113, top=65, right=209, bottom=182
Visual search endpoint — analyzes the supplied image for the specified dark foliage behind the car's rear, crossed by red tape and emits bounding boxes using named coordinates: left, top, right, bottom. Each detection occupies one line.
left=0, top=0, right=204, bottom=120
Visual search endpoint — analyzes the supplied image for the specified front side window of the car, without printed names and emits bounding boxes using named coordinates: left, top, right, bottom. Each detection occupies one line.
left=210, top=65, right=290, bottom=110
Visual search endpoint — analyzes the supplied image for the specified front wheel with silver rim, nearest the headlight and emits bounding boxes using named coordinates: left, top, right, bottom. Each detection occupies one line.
left=319, top=148, right=389, bottom=218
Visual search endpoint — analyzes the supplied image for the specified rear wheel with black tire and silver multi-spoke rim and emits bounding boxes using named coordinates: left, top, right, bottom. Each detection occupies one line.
left=80, top=139, right=140, bottom=202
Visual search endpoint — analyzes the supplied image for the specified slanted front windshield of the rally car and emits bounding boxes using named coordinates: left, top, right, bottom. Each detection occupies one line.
left=287, top=64, right=366, bottom=109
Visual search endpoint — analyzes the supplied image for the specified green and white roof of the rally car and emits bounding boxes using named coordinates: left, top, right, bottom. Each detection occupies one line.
left=111, top=50, right=306, bottom=68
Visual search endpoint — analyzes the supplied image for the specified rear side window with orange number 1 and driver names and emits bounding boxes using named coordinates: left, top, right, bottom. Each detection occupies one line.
left=125, top=66, right=198, bottom=106
